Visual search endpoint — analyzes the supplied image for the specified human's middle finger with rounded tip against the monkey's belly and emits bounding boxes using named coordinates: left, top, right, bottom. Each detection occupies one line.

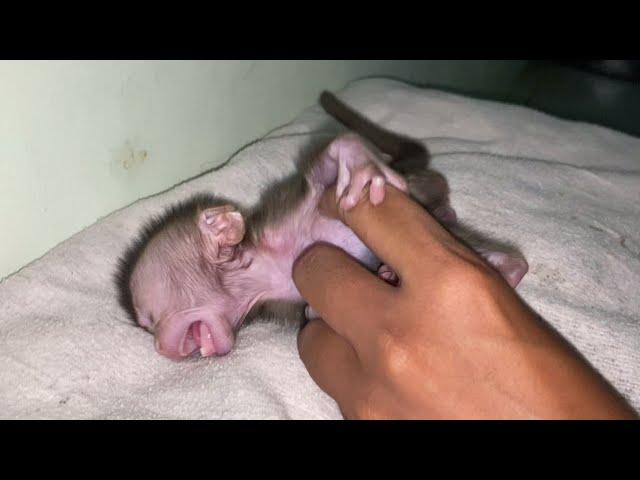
left=293, top=244, right=397, bottom=353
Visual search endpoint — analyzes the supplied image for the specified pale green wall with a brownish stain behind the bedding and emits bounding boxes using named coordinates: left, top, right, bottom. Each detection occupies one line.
left=0, top=60, right=526, bottom=278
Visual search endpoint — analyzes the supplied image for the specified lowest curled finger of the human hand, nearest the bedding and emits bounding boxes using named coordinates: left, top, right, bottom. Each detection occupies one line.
left=298, top=320, right=364, bottom=417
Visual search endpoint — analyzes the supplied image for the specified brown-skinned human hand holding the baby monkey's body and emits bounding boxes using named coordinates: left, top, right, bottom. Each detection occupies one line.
left=293, top=185, right=637, bottom=419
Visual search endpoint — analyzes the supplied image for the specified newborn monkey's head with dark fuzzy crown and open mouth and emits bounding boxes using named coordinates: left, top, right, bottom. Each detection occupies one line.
left=116, top=195, right=253, bottom=360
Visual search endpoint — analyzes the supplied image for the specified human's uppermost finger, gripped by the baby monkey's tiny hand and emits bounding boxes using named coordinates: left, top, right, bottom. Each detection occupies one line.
left=319, top=184, right=465, bottom=279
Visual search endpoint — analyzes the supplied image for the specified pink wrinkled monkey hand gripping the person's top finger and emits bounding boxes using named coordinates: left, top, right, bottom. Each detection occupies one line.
left=312, top=133, right=408, bottom=210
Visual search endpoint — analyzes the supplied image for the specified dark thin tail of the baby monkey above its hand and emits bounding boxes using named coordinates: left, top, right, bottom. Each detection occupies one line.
left=320, top=90, right=429, bottom=174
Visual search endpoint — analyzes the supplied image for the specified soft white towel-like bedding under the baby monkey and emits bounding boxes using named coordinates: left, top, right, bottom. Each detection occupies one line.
left=0, top=79, right=640, bottom=419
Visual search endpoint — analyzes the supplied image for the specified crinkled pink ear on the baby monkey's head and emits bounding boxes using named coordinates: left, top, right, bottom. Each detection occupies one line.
left=198, top=205, right=245, bottom=257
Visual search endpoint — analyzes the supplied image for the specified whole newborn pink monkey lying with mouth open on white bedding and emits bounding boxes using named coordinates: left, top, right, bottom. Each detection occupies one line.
left=116, top=92, right=528, bottom=360
